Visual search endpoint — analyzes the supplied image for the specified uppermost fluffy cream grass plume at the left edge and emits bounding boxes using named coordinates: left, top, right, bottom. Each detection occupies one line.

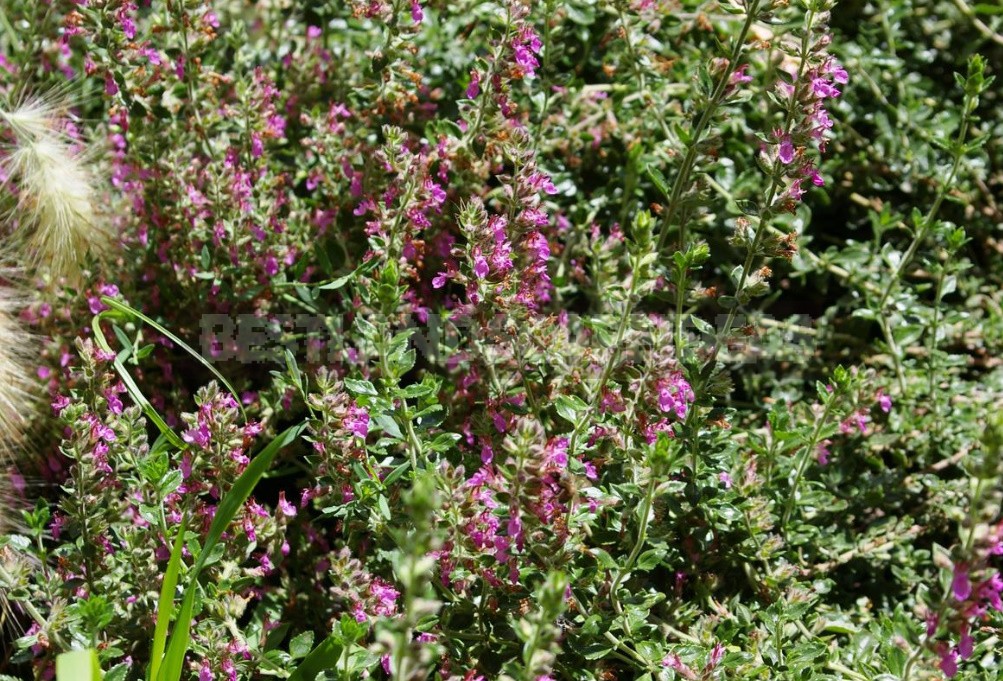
left=0, top=88, right=109, bottom=285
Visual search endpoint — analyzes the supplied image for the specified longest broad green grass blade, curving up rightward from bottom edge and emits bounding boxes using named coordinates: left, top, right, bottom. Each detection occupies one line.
left=156, top=423, right=307, bottom=681
